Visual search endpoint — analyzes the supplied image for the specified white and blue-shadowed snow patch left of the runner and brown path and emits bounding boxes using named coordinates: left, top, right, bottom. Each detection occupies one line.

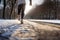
left=0, top=20, right=21, bottom=37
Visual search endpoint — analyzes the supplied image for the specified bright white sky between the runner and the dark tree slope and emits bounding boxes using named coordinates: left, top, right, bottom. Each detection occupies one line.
left=25, top=0, right=44, bottom=14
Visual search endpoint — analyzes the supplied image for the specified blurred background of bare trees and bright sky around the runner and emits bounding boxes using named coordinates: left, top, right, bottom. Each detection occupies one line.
left=0, top=0, right=60, bottom=20
